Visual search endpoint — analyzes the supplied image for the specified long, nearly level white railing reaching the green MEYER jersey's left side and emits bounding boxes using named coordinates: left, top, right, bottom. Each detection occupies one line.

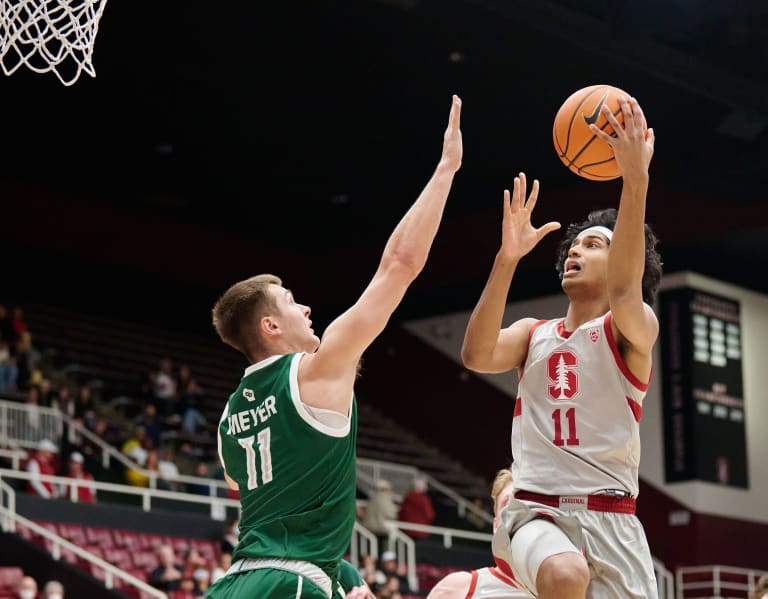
left=0, top=468, right=240, bottom=520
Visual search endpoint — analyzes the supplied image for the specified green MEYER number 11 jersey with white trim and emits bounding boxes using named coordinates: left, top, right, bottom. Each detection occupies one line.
left=219, top=354, right=357, bottom=580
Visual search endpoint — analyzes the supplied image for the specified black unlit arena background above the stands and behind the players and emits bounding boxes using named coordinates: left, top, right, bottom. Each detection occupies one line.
left=0, top=0, right=768, bottom=332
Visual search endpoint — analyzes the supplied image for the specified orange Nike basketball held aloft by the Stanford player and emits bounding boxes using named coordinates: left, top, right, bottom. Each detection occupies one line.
left=552, top=85, right=630, bottom=181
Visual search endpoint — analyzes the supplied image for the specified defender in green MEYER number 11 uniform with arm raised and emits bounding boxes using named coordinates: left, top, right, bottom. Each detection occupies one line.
left=206, top=96, right=462, bottom=599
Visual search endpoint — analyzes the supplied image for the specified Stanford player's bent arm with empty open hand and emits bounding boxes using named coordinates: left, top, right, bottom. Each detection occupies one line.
left=461, top=173, right=560, bottom=372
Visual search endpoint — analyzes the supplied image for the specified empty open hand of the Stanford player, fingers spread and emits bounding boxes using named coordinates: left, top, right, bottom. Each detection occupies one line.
left=501, top=173, right=560, bottom=260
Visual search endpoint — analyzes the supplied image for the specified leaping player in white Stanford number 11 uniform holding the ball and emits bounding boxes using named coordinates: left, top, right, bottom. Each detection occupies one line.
left=462, top=98, right=661, bottom=599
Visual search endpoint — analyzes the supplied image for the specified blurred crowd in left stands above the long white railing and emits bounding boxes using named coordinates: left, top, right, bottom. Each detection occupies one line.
left=0, top=304, right=228, bottom=501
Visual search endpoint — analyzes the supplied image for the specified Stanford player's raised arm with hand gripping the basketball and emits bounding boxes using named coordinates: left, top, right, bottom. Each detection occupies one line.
left=590, top=97, right=659, bottom=360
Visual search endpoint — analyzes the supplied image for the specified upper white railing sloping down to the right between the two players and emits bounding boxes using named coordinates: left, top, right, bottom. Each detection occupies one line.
left=357, top=458, right=493, bottom=524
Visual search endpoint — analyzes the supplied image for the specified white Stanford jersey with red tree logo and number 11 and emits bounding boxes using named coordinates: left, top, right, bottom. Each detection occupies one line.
left=512, top=312, right=648, bottom=497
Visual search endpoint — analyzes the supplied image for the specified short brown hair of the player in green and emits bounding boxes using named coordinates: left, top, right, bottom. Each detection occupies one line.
left=212, top=274, right=283, bottom=360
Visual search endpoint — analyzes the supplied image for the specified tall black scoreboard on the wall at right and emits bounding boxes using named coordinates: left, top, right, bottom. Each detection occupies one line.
left=659, top=287, right=749, bottom=488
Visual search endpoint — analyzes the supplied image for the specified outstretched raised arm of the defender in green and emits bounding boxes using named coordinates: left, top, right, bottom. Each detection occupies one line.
left=299, top=96, right=463, bottom=414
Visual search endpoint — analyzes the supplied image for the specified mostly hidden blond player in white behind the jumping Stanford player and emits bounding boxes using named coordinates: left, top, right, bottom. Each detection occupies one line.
left=427, top=468, right=531, bottom=599
